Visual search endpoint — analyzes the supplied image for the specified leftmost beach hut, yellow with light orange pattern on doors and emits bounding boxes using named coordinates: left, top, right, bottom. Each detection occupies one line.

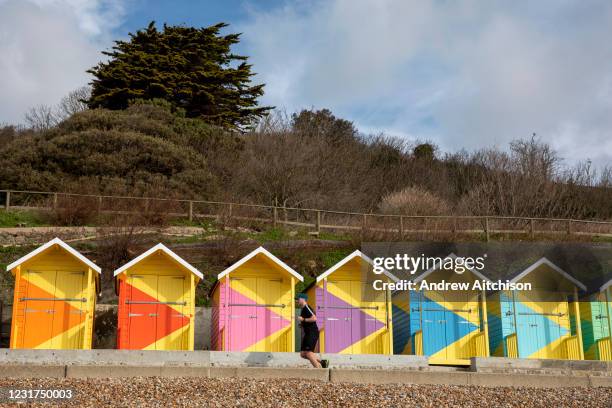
left=6, top=238, right=100, bottom=349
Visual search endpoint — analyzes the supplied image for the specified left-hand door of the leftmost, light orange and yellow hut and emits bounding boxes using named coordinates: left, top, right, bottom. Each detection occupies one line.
left=18, top=270, right=56, bottom=348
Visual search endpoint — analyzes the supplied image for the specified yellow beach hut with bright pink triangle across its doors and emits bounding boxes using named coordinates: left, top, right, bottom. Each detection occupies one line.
left=211, top=247, right=304, bottom=352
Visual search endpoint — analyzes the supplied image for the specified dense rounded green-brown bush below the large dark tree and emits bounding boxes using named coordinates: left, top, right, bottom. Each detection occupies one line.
left=0, top=104, right=240, bottom=197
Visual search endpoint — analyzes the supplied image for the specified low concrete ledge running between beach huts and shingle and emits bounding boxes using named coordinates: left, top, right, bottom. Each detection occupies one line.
left=0, top=350, right=612, bottom=388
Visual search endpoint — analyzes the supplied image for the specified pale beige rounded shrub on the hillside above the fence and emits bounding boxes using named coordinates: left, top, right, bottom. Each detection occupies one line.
left=380, top=187, right=451, bottom=215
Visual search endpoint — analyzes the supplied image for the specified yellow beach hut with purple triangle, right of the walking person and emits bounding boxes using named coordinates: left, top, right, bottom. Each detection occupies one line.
left=307, top=250, right=397, bottom=354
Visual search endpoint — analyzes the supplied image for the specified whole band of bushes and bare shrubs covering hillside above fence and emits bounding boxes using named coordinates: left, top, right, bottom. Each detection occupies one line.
left=0, top=101, right=612, bottom=219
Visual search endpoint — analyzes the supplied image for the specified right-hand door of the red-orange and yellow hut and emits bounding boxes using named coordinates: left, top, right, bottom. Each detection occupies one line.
left=155, top=275, right=189, bottom=350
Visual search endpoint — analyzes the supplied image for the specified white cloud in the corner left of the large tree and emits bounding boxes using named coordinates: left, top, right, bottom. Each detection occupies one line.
left=0, top=0, right=124, bottom=123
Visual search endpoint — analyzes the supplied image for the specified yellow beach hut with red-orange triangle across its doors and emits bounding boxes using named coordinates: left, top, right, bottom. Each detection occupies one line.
left=115, top=244, right=202, bottom=350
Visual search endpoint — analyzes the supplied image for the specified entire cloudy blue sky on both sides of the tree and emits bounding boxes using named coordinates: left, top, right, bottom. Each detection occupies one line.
left=0, top=0, right=612, bottom=166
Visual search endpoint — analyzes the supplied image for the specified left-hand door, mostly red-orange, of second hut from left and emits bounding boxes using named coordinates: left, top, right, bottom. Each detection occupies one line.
left=127, top=275, right=157, bottom=350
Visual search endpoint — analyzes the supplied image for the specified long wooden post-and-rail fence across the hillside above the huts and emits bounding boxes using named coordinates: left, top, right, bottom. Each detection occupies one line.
left=0, top=190, right=612, bottom=241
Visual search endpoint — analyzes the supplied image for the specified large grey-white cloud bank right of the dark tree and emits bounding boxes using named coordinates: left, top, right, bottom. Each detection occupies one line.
left=239, top=0, right=612, bottom=164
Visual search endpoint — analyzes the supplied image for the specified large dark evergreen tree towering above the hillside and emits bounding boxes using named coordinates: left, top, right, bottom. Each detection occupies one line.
left=88, top=22, right=271, bottom=129
